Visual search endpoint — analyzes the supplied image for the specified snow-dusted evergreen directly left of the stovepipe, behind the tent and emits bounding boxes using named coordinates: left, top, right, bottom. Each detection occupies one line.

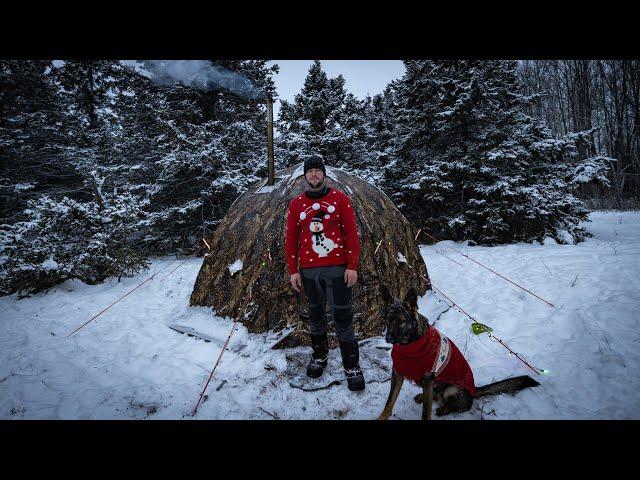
left=135, top=61, right=274, bottom=252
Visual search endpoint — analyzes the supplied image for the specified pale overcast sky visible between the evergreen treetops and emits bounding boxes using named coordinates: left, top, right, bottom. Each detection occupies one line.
left=264, top=60, right=404, bottom=119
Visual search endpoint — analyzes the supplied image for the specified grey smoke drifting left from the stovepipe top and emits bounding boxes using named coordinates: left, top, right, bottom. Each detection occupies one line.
left=142, top=60, right=265, bottom=100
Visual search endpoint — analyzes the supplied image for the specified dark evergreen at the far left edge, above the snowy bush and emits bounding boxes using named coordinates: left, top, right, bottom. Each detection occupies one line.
left=0, top=60, right=88, bottom=224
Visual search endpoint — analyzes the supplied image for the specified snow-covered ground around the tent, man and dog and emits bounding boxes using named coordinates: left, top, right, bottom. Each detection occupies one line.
left=0, top=212, right=640, bottom=420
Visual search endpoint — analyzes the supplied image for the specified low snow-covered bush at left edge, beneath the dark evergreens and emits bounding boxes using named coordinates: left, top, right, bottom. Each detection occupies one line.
left=0, top=195, right=148, bottom=295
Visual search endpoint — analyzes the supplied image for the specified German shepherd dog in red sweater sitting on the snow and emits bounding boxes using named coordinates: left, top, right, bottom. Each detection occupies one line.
left=378, top=286, right=540, bottom=420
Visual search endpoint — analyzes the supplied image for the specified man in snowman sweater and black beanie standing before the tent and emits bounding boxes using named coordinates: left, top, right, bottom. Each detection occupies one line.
left=285, top=155, right=365, bottom=391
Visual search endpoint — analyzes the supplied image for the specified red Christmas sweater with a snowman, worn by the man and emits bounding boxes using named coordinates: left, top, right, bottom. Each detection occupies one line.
left=285, top=188, right=360, bottom=274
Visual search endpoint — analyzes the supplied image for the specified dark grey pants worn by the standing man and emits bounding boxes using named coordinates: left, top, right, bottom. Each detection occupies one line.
left=300, top=265, right=355, bottom=342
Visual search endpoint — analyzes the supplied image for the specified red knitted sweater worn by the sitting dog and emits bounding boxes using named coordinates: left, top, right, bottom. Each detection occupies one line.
left=391, top=326, right=476, bottom=397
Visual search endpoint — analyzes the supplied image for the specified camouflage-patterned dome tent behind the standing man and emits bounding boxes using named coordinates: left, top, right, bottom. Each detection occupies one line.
left=190, top=163, right=431, bottom=348
